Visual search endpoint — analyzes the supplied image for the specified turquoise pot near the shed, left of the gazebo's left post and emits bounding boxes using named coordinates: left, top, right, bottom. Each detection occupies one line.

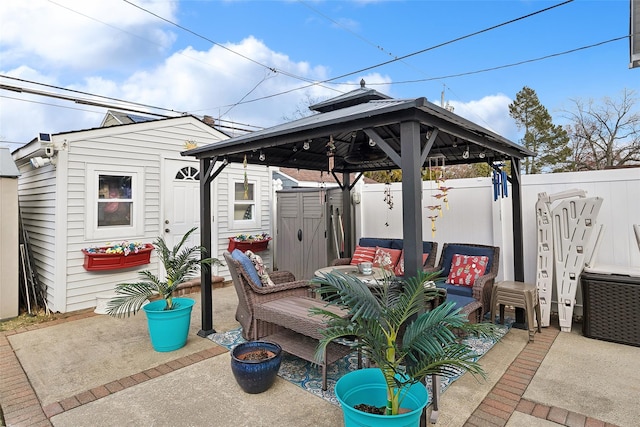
left=142, top=298, right=195, bottom=352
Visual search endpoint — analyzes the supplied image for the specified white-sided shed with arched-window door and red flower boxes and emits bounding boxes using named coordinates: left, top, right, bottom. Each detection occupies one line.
left=13, top=112, right=271, bottom=312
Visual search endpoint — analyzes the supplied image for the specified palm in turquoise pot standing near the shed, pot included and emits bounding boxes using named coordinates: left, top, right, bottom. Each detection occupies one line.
left=107, top=227, right=221, bottom=352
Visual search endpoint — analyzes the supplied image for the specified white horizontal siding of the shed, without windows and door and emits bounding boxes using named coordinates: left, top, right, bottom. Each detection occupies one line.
left=14, top=116, right=270, bottom=312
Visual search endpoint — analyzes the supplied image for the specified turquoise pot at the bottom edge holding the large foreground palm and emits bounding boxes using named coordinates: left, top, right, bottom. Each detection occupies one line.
left=335, top=368, right=429, bottom=427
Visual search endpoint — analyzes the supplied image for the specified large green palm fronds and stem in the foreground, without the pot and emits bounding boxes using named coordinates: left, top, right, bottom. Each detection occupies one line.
left=312, top=271, right=496, bottom=415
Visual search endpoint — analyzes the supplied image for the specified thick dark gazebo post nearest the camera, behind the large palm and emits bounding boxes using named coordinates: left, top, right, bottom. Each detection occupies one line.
left=400, top=121, right=422, bottom=277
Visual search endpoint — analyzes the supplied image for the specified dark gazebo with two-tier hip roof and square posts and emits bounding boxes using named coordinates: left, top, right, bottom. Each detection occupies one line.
left=182, top=81, right=535, bottom=336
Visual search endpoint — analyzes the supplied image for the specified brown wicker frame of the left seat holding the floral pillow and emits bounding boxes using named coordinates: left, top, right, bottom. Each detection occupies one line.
left=223, top=251, right=313, bottom=340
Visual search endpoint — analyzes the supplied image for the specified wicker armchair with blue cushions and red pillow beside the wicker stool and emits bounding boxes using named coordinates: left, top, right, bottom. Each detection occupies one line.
left=430, top=243, right=500, bottom=322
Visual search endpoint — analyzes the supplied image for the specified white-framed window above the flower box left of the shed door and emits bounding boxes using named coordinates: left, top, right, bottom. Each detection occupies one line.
left=85, top=165, right=144, bottom=241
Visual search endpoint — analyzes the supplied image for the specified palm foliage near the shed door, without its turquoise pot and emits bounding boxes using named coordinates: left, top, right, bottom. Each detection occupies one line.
left=107, top=227, right=222, bottom=317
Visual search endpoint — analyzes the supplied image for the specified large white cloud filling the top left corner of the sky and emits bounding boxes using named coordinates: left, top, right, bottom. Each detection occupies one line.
left=0, top=0, right=175, bottom=70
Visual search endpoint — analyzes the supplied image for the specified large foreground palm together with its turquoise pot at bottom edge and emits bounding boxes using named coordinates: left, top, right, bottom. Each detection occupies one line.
left=313, top=271, right=496, bottom=427
